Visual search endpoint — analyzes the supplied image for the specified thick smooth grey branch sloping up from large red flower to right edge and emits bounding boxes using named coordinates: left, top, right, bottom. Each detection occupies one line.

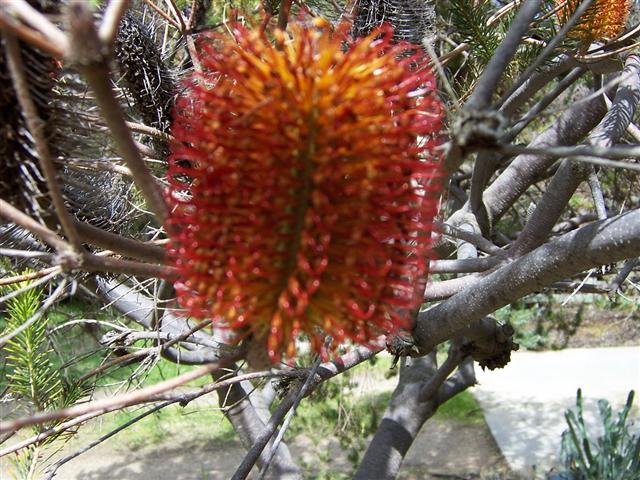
left=413, top=210, right=640, bottom=352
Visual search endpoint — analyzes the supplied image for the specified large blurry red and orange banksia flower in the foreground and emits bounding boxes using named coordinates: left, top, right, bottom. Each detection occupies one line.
left=166, top=20, right=442, bottom=362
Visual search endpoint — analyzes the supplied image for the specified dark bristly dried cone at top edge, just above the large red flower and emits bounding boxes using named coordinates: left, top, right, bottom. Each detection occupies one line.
left=353, top=0, right=435, bottom=45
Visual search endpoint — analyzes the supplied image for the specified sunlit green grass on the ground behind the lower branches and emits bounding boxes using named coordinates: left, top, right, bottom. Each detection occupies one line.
left=0, top=292, right=483, bottom=479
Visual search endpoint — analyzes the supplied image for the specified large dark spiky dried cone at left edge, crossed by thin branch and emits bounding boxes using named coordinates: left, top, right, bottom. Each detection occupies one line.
left=0, top=0, right=150, bottom=244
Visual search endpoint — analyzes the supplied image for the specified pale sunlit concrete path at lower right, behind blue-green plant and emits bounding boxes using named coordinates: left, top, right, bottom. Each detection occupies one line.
left=471, top=346, right=640, bottom=478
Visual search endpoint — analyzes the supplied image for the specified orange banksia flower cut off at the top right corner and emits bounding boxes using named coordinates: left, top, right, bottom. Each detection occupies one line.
left=556, top=0, right=631, bottom=44
